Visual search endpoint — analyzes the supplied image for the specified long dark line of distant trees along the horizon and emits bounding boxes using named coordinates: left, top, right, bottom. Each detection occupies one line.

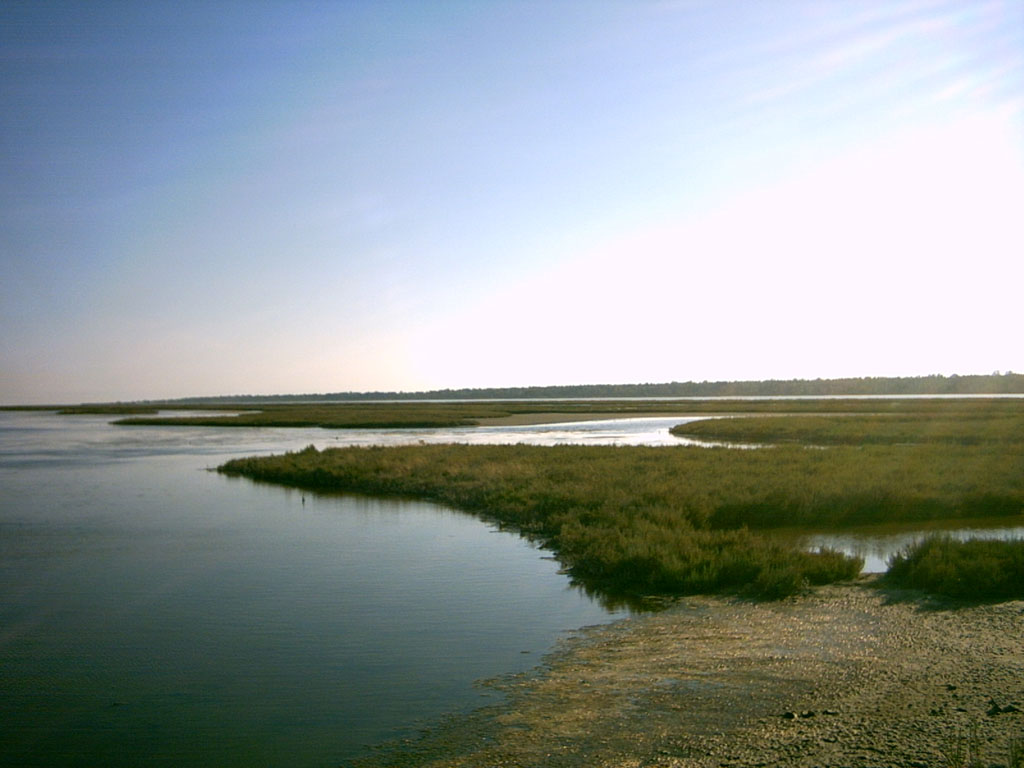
left=165, top=372, right=1024, bottom=403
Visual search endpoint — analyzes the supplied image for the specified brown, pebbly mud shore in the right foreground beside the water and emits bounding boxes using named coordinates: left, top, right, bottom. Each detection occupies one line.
left=360, top=583, right=1024, bottom=768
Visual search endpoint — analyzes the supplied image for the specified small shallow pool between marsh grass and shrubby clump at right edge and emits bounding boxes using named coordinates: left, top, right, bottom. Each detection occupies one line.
left=794, top=517, right=1024, bottom=573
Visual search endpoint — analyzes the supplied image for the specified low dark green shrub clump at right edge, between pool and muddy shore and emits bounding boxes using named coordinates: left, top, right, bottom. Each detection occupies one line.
left=886, top=536, right=1024, bottom=600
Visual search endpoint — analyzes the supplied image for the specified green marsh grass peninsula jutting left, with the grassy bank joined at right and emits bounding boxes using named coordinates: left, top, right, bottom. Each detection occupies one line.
left=220, top=402, right=1024, bottom=597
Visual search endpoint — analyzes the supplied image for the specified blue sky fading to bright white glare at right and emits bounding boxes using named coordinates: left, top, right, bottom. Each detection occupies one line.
left=0, top=0, right=1024, bottom=404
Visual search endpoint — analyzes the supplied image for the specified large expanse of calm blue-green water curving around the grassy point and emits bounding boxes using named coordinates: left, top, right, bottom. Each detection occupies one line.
left=0, top=413, right=688, bottom=766
